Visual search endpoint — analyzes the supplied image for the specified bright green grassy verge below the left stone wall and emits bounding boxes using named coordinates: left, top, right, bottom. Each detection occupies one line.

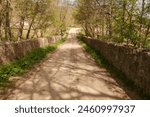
left=0, top=39, right=65, bottom=87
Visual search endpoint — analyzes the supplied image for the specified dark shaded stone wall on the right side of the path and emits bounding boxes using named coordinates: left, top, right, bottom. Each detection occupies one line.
left=83, top=38, right=150, bottom=95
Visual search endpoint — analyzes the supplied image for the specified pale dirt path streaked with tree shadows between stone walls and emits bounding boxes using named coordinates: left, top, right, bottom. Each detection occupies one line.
left=0, top=29, right=139, bottom=100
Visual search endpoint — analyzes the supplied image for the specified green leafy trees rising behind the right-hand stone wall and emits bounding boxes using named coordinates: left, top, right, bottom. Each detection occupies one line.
left=75, top=0, right=150, bottom=47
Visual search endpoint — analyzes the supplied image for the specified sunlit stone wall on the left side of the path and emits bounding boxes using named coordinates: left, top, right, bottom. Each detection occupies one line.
left=0, top=36, right=61, bottom=64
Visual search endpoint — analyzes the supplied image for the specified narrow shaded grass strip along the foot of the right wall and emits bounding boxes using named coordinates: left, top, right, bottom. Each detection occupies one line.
left=77, top=35, right=150, bottom=99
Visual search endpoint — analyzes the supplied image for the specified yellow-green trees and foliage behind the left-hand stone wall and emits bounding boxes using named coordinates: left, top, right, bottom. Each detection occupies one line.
left=0, top=0, right=74, bottom=41
